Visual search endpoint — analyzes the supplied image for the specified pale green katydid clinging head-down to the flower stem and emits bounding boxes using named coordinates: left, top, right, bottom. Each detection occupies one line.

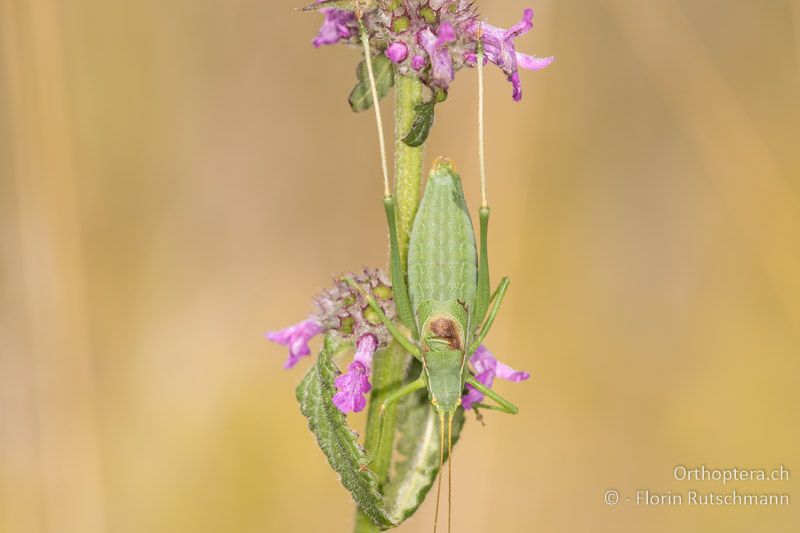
left=348, top=158, right=517, bottom=531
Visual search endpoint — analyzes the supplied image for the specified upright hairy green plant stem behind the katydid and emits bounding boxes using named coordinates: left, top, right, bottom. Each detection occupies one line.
left=354, top=75, right=425, bottom=533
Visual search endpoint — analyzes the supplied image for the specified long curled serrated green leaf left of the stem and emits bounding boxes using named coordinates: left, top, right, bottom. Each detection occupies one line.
left=296, top=335, right=395, bottom=529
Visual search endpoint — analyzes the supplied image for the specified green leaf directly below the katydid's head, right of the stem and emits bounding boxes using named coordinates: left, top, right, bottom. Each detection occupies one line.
left=384, top=361, right=464, bottom=524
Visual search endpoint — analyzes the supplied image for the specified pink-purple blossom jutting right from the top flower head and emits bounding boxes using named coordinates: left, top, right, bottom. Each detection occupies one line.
left=466, top=8, right=554, bottom=102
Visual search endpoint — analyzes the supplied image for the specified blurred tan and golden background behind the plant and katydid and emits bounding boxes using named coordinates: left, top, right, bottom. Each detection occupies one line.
left=0, top=0, right=800, bottom=533
